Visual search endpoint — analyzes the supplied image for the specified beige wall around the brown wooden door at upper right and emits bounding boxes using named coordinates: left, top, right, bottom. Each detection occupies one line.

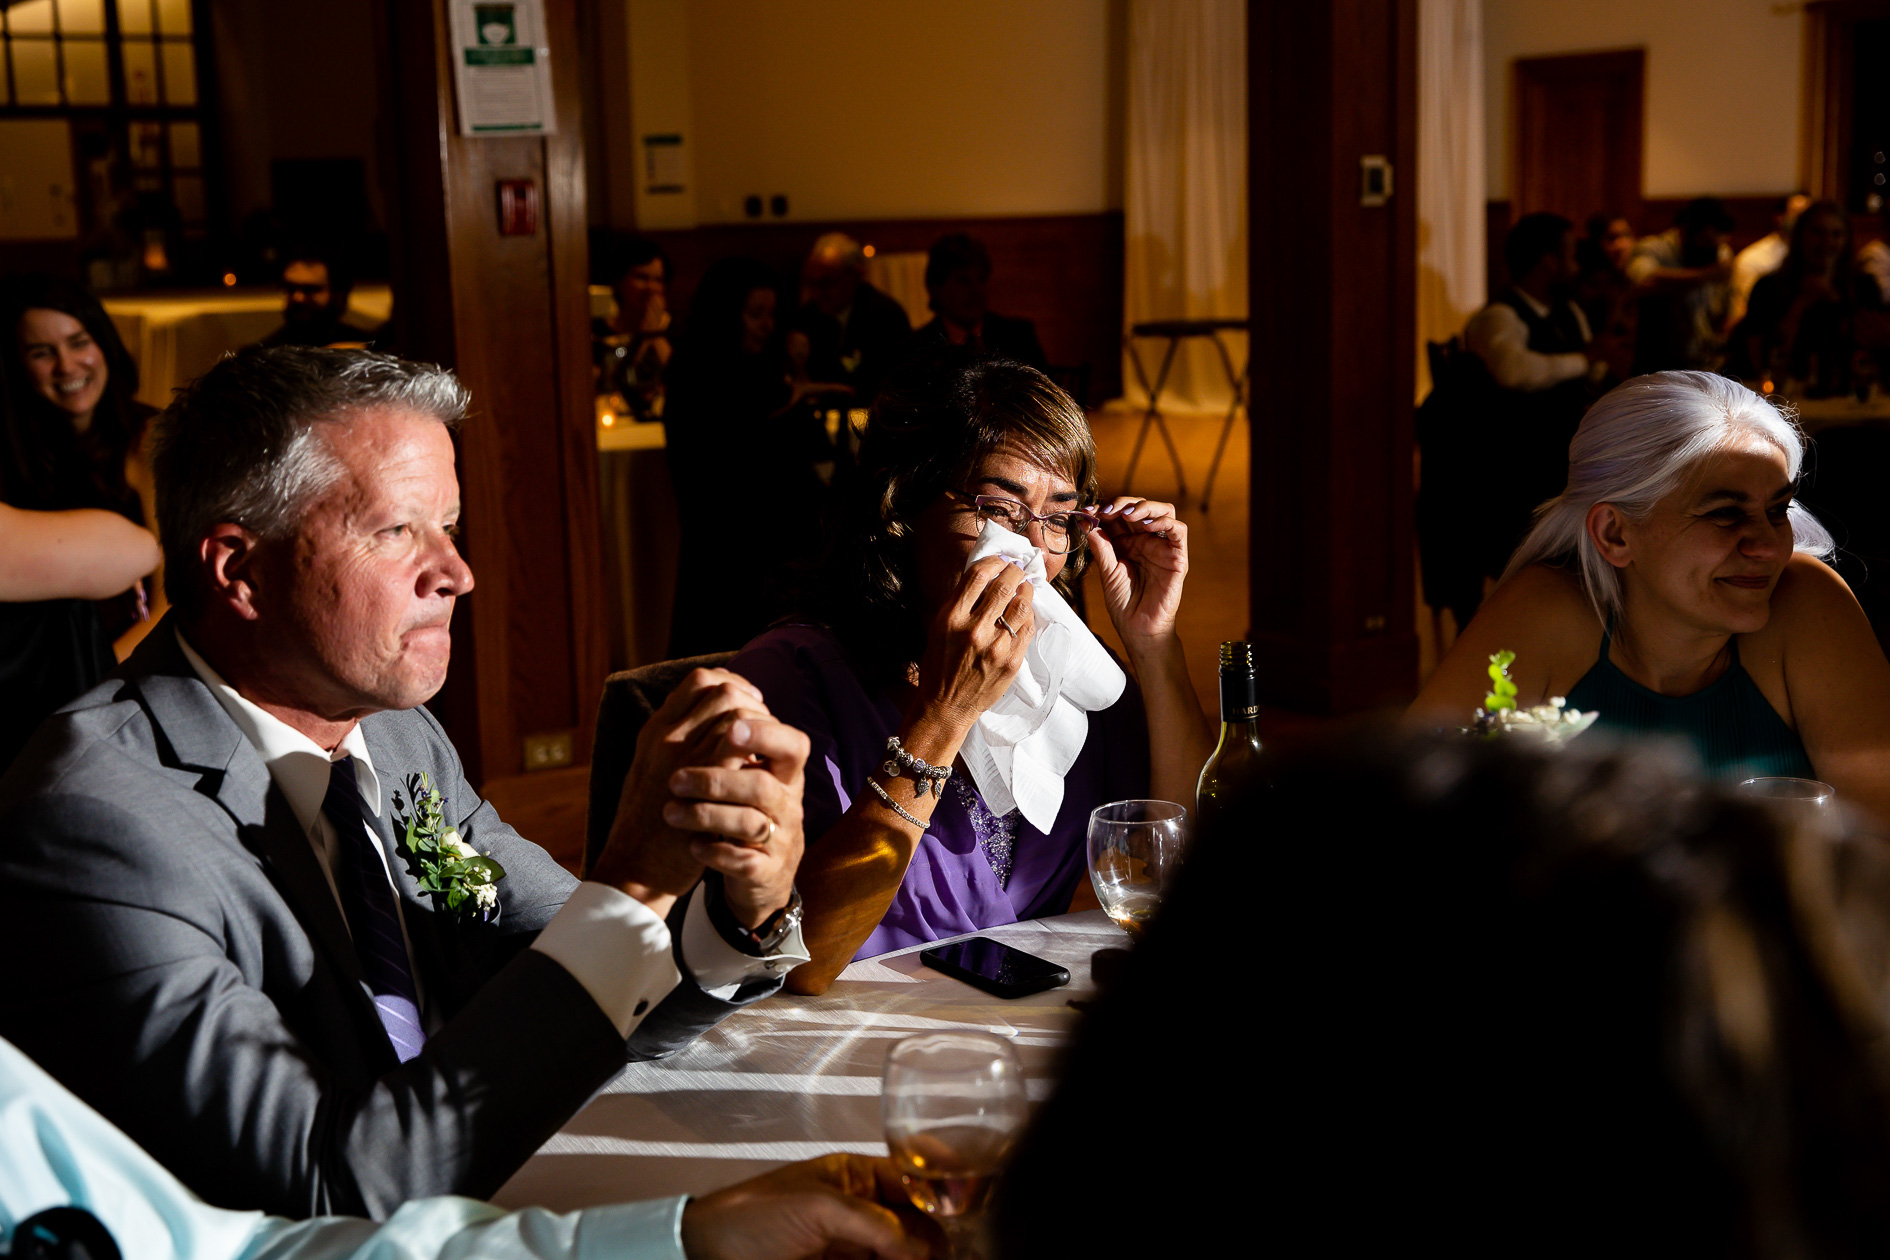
left=1484, top=0, right=1805, bottom=200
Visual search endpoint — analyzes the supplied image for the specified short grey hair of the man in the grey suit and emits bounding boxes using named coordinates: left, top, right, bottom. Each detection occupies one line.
left=151, top=346, right=471, bottom=616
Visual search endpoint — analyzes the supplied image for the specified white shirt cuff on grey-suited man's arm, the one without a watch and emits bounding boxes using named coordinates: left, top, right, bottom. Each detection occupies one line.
left=531, top=880, right=682, bottom=1039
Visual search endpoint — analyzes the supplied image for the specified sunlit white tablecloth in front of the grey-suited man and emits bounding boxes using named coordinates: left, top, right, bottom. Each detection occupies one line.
left=493, top=911, right=1128, bottom=1211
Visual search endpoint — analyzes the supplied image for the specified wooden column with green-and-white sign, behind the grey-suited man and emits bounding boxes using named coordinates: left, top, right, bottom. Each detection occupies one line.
left=382, top=0, right=607, bottom=782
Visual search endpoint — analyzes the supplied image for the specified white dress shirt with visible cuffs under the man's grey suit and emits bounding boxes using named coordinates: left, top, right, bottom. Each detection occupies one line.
left=178, top=631, right=809, bottom=1039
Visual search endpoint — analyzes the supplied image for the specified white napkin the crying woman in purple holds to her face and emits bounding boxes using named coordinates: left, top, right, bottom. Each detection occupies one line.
left=958, top=521, right=1128, bottom=831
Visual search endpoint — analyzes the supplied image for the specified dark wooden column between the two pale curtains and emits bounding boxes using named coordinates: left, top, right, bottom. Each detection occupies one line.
left=1247, top=0, right=1421, bottom=712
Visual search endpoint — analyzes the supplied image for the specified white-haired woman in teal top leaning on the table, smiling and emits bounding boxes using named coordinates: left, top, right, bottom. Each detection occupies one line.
left=1412, top=372, right=1890, bottom=820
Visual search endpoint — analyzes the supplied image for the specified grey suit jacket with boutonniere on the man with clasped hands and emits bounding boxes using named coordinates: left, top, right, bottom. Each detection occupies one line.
left=0, top=623, right=779, bottom=1218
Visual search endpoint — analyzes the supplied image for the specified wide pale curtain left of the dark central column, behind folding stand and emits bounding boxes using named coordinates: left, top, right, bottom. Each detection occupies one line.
left=1123, top=0, right=1247, bottom=412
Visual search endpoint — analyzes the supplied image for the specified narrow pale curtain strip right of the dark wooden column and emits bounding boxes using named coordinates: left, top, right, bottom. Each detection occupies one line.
left=1416, top=0, right=1487, bottom=399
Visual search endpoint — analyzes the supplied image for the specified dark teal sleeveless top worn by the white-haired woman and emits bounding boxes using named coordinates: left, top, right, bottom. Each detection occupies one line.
left=1569, top=620, right=1816, bottom=778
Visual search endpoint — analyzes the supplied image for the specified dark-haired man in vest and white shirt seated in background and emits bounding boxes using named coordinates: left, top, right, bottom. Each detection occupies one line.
left=1463, top=213, right=1625, bottom=576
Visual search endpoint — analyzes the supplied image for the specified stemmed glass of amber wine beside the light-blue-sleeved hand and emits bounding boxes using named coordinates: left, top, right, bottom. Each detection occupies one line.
left=879, top=1031, right=1028, bottom=1256
